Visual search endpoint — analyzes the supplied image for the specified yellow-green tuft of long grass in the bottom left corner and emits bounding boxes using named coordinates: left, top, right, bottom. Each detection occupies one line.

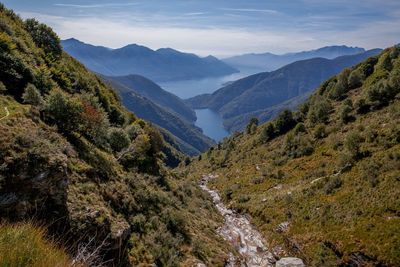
left=0, top=223, right=72, bottom=267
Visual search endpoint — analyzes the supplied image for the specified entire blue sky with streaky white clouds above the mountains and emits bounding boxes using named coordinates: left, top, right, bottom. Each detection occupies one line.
left=1, top=0, right=400, bottom=57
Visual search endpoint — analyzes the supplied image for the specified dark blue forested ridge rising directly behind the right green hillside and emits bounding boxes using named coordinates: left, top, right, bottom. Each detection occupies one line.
left=187, top=49, right=380, bottom=132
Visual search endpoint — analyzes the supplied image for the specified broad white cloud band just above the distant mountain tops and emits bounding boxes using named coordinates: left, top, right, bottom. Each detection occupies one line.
left=18, top=13, right=400, bottom=57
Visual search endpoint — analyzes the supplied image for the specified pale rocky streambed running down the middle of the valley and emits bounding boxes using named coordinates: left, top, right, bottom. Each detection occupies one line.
left=200, top=175, right=304, bottom=267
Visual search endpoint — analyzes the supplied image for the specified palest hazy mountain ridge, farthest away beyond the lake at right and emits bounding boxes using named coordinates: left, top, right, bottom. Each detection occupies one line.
left=223, top=45, right=365, bottom=72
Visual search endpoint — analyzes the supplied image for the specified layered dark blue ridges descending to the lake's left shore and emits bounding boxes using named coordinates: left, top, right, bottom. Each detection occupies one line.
left=102, top=75, right=214, bottom=156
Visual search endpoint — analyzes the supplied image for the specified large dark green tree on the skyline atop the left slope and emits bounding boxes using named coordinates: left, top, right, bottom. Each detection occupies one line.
left=25, top=19, right=62, bottom=59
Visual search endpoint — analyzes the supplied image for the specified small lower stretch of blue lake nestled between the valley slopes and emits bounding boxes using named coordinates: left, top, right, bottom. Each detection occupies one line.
left=195, top=109, right=229, bottom=142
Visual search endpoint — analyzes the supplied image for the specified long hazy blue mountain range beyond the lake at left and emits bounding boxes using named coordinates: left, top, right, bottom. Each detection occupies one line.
left=62, top=39, right=237, bottom=82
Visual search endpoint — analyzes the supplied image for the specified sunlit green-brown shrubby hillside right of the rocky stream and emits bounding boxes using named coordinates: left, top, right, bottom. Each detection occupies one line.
left=185, top=46, right=400, bottom=266
